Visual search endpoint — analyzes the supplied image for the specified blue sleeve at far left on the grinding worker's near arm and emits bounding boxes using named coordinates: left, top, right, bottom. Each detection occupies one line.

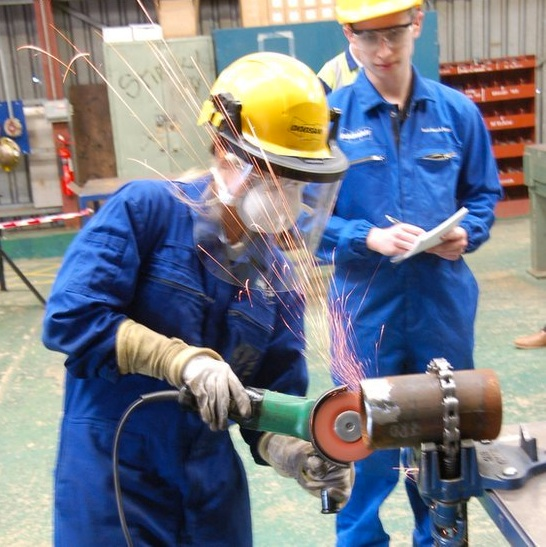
left=42, top=181, right=173, bottom=381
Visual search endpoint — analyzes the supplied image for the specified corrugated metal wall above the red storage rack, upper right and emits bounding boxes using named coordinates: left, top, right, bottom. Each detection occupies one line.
left=427, top=0, right=546, bottom=142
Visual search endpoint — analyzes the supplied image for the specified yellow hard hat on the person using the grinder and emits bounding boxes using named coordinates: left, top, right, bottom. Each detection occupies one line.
left=198, top=52, right=347, bottom=182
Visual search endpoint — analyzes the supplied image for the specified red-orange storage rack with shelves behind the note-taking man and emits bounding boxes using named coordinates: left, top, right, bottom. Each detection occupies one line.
left=440, top=55, right=536, bottom=216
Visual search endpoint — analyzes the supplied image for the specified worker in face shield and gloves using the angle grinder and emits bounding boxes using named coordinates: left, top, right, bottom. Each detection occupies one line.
left=43, top=52, right=352, bottom=547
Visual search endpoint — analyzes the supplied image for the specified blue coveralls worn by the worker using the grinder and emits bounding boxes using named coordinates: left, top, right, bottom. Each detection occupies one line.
left=43, top=181, right=308, bottom=547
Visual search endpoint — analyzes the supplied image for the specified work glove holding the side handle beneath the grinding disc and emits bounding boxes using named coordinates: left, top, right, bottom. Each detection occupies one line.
left=258, top=433, right=354, bottom=507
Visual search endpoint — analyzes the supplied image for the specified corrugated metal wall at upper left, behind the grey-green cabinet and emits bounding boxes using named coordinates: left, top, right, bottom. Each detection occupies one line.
left=0, top=0, right=240, bottom=102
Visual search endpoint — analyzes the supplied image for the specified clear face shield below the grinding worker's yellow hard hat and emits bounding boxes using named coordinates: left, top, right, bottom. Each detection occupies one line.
left=194, top=153, right=339, bottom=293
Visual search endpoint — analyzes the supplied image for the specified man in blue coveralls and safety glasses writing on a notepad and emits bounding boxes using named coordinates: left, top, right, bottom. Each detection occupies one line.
left=318, top=0, right=502, bottom=547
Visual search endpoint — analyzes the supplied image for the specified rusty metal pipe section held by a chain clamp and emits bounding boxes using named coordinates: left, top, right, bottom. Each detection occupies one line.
left=360, top=369, right=502, bottom=449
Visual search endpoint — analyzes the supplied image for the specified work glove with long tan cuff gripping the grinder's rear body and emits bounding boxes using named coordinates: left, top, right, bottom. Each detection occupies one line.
left=116, top=319, right=251, bottom=431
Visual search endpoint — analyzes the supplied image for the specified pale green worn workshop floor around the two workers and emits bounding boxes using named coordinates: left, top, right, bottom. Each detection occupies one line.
left=0, top=217, right=546, bottom=547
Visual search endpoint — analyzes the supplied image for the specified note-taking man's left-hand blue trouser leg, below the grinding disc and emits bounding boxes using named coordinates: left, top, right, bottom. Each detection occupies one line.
left=336, top=449, right=400, bottom=547
